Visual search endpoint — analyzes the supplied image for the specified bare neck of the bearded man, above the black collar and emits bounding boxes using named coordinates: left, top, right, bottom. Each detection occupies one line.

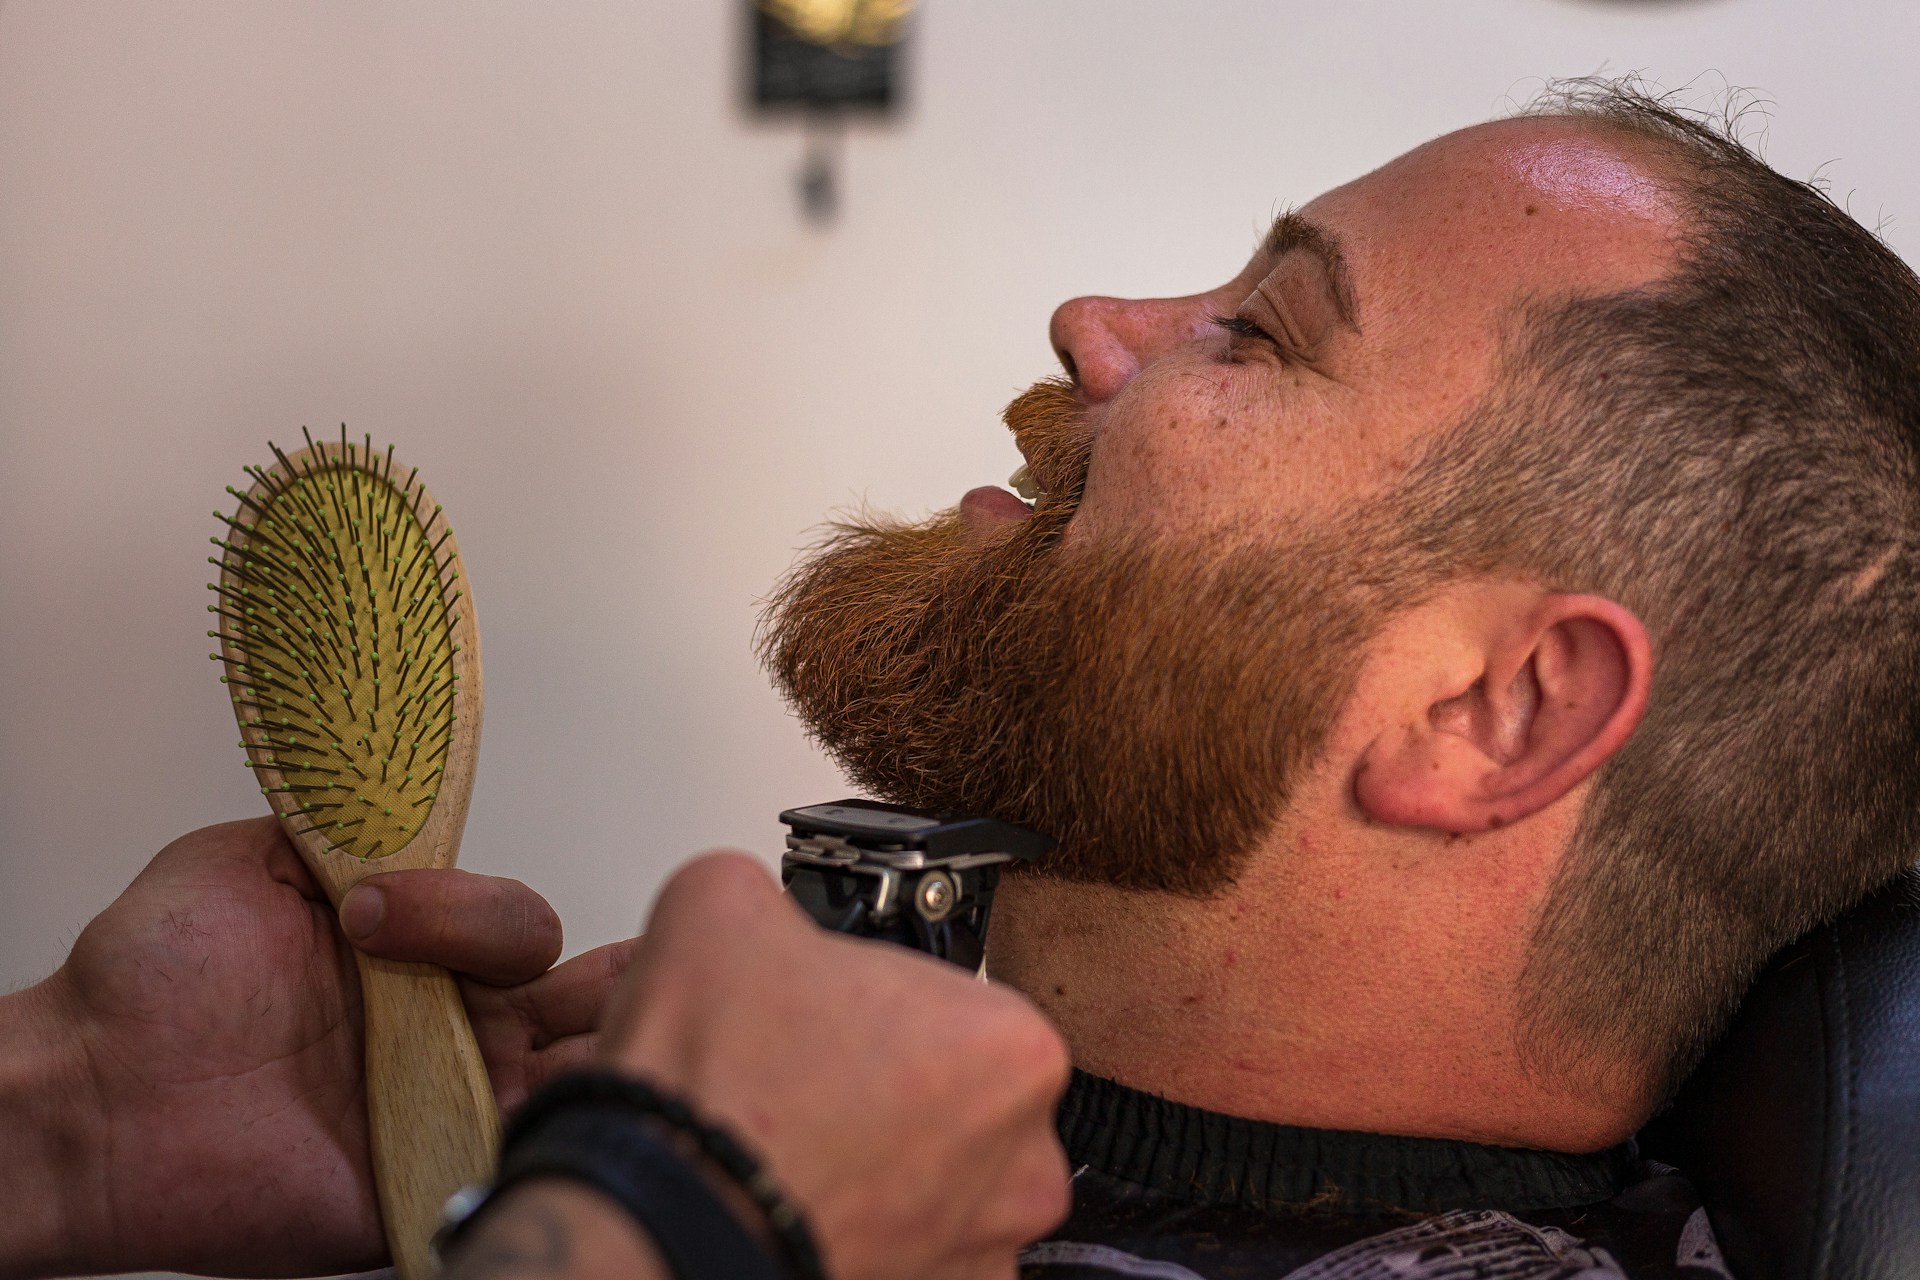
left=989, top=825, right=1644, bottom=1151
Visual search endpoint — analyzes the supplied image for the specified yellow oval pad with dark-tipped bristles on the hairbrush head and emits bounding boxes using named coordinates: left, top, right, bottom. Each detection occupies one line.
left=207, top=429, right=459, bottom=858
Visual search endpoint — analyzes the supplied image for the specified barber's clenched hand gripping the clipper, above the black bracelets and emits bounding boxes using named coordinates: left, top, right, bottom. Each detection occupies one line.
left=597, top=854, right=1068, bottom=1280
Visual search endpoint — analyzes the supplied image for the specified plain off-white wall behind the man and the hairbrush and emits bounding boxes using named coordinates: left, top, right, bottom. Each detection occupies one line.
left=0, top=0, right=1920, bottom=988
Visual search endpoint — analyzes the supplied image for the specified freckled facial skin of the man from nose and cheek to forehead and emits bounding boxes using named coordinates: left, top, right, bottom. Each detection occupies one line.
left=1052, top=121, right=1670, bottom=537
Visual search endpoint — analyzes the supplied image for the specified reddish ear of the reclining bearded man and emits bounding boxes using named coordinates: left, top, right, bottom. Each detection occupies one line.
left=1354, top=595, right=1653, bottom=833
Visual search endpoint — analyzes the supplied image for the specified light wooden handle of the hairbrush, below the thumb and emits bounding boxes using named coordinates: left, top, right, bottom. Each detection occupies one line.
left=355, top=952, right=499, bottom=1280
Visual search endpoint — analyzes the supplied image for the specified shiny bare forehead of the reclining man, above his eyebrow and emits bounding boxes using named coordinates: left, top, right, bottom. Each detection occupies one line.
left=1302, top=117, right=1680, bottom=433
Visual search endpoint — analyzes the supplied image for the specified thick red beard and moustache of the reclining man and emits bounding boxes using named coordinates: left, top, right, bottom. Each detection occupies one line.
left=760, top=382, right=1405, bottom=894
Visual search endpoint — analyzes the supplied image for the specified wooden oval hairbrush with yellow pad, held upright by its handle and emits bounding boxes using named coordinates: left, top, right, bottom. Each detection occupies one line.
left=207, top=426, right=499, bottom=1280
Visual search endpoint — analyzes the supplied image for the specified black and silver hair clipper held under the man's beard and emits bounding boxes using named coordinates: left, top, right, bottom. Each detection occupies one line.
left=780, top=800, right=1054, bottom=971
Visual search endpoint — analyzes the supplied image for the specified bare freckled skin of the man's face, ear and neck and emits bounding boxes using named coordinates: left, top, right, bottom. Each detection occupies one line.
left=989, top=119, right=1678, bottom=1151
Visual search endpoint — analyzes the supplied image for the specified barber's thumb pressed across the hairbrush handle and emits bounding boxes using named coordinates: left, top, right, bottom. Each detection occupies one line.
left=340, top=869, right=561, bottom=986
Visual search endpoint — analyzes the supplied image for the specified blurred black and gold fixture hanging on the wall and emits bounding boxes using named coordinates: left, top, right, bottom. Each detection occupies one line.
left=747, top=0, right=916, bottom=223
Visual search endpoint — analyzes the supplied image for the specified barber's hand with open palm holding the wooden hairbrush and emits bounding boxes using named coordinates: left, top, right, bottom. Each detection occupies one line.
left=24, top=818, right=626, bottom=1276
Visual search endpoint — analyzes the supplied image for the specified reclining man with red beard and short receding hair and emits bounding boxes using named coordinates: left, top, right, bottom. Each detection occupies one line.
left=762, top=84, right=1920, bottom=1280
